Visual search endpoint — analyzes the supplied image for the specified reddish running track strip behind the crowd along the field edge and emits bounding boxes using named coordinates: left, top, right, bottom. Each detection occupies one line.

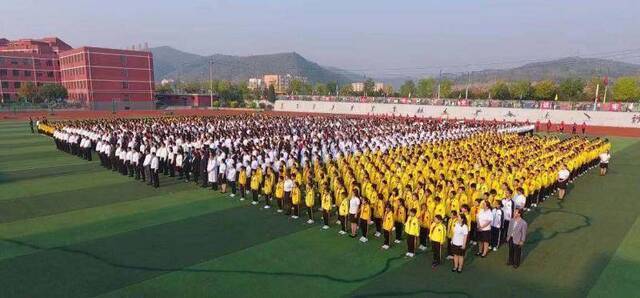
left=0, top=109, right=640, bottom=137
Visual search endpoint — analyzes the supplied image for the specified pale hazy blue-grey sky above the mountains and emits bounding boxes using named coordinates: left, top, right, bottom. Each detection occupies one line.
left=0, top=0, right=640, bottom=75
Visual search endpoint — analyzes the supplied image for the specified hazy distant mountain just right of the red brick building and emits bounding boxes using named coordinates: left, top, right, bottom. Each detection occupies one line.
left=151, top=46, right=352, bottom=83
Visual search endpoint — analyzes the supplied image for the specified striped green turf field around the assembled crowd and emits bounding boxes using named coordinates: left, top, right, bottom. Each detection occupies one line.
left=0, top=122, right=640, bottom=297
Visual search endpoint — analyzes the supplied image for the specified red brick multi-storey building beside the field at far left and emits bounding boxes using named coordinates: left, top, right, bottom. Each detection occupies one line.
left=0, top=38, right=154, bottom=108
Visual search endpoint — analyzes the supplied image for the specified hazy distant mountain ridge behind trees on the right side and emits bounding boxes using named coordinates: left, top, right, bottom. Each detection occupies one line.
left=447, top=57, right=640, bottom=83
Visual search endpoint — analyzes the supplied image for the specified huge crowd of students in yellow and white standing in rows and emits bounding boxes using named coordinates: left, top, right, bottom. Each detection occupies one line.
left=40, top=115, right=610, bottom=272
